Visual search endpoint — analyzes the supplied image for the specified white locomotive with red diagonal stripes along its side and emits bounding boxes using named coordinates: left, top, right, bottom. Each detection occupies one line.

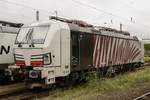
left=5, top=17, right=144, bottom=87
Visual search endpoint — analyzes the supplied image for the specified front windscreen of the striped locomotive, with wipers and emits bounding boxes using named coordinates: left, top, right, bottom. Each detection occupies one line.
left=16, top=25, right=50, bottom=44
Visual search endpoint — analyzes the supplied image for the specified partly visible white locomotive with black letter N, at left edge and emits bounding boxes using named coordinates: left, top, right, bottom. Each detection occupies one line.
left=0, top=21, right=22, bottom=81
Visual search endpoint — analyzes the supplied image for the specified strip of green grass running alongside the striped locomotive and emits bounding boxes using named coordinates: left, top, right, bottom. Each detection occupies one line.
left=46, top=67, right=150, bottom=100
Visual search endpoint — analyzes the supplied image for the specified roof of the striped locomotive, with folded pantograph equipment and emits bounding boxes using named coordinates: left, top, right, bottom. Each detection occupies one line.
left=23, top=17, right=138, bottom=40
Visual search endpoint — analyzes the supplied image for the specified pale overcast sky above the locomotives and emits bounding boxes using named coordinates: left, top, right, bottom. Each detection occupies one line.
left=0, top=0, right=150, bottom=38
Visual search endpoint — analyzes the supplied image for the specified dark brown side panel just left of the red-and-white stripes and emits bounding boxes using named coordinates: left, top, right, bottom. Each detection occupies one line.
left=79, top=33, right=93, bottom=69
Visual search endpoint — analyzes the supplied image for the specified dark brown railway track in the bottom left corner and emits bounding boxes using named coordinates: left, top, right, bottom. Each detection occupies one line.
left=0, top=85, right=50, bottom=100
